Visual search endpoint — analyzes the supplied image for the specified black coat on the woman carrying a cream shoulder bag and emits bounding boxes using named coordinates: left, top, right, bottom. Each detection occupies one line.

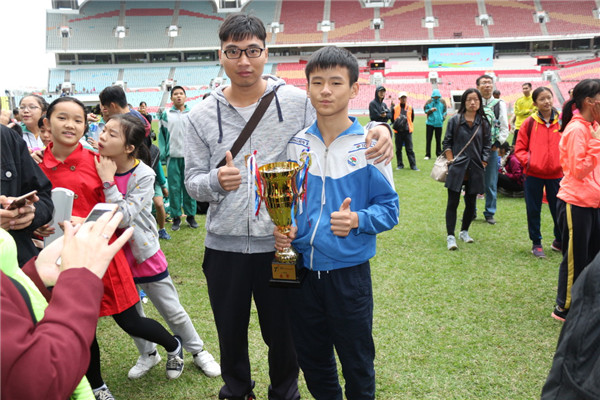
left=443, top=114, right=492, bottom=194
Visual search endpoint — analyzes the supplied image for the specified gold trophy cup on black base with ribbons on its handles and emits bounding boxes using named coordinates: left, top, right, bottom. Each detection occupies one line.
left=258, top=161, right=306, bottom=287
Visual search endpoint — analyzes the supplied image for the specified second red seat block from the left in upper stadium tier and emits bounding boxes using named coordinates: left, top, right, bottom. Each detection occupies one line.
left=328, top=0, right=375, bottom=43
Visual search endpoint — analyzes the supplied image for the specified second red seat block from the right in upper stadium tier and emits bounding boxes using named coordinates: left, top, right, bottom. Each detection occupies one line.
left=485, top=0, right=542, bottom=37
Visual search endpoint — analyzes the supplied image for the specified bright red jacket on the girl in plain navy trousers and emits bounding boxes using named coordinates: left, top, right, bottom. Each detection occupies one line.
left=515, top=112, right=563, bottom=179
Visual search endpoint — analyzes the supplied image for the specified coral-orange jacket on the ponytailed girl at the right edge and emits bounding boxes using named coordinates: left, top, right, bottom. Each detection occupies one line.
left=556, top=114, right=600, bottom=208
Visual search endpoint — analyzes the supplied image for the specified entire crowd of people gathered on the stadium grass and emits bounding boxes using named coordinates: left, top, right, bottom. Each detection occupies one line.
left=0, top=13, right=600, bottom=400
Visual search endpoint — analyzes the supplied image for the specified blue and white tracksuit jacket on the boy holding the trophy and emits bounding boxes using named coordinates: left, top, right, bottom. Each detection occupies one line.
left=287, top=117, right=399, bottom=271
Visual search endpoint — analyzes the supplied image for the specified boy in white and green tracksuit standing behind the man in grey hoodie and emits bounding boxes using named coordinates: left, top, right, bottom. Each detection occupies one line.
left=158, top=86, right=198, bottom=231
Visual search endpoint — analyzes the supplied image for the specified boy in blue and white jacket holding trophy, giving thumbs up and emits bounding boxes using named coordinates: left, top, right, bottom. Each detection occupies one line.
left=274, top=47, right=398, bottom=400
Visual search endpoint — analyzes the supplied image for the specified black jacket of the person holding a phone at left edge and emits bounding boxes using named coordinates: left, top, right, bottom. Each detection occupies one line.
left=0, top=125, right=54, bottom=266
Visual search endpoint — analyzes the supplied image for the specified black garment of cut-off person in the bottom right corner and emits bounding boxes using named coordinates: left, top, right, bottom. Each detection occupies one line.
left=542, top=253, right=600, bottom=400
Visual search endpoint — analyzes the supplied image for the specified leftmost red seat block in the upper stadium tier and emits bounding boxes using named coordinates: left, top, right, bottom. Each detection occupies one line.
left=277, top=0, right=325, bottom=44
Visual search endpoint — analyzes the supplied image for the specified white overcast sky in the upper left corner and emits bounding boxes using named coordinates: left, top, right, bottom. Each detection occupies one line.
left=0, top=0, right=55, bottom=95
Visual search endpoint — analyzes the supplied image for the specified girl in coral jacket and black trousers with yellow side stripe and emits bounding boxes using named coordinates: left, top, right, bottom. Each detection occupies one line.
left=552, top=79, right=600, bottom=321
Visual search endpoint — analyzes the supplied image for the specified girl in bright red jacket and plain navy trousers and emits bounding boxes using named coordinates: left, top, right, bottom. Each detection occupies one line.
left=515, top=87, right=563, bottom=258
